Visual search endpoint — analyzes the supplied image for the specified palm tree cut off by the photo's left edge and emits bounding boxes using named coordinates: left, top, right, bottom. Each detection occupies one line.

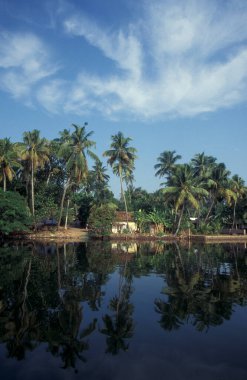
left=0, top=138, right=20, bottom=191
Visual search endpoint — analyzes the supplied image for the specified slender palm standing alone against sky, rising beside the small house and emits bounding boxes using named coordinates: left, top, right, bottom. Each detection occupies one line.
left=103, top=132, right=136, bottom=227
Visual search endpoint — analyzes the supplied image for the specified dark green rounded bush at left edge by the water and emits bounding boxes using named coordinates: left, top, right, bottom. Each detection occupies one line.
left=0, top=189, right=32, bottom=235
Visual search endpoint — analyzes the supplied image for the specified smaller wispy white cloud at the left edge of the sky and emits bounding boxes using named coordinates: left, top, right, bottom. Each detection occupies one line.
left=0, top=32, right=57, bottom=98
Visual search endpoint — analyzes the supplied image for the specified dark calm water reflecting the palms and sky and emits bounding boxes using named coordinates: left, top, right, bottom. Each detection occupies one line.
left=0, top=243, right=247, bottom=380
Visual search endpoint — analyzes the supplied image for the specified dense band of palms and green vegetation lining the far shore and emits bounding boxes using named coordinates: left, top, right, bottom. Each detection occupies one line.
left=0, top=123, right=247, bottom=234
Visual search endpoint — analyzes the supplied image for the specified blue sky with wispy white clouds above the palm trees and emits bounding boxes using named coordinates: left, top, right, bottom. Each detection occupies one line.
left=0, top=0, right=247, bottom=194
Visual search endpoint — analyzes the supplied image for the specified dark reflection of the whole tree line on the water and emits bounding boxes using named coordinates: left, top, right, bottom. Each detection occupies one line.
left=0, top=242, right=247, bottom=371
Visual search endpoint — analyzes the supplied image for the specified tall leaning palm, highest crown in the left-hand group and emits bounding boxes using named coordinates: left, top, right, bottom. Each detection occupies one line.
left=58, top=123, right=98, bottom=226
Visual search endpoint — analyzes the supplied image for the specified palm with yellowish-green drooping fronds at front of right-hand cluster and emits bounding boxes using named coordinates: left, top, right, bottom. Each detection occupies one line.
left=163, top=164, right=208, bottom=235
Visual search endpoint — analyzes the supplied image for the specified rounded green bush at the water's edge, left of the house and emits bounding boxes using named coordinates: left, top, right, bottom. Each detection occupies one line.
left=88, top=203, right=116, bottom=236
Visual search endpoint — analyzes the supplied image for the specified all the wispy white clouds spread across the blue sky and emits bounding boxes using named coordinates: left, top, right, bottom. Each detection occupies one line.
left=0, top=0, right=247, bottom=119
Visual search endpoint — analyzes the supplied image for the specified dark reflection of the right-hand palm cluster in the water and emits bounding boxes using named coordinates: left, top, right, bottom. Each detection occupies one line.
left=155, top=245, right=247, bottom=332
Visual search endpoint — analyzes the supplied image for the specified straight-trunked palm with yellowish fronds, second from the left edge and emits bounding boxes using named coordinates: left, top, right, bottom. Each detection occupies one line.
left=21, top=129, right=49, bottom=215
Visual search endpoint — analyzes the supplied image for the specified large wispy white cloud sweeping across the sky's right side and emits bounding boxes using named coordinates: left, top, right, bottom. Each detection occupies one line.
left=56, top=1, right=247, bottom=118
